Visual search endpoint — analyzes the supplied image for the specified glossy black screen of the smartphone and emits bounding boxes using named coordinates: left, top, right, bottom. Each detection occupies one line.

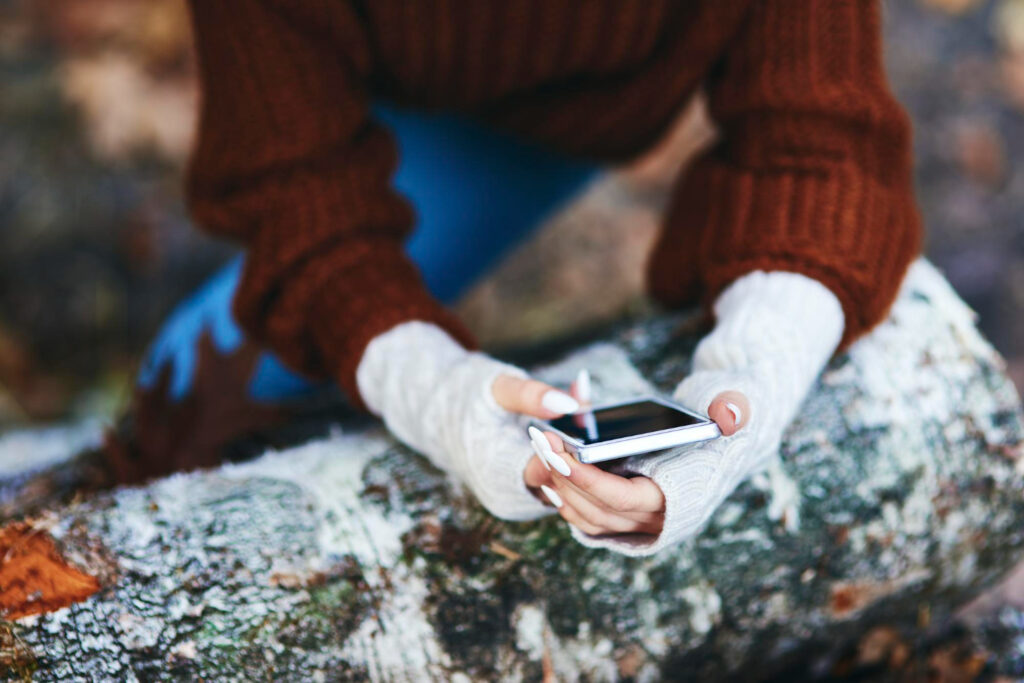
left=551, top=400, right=705, bottom=444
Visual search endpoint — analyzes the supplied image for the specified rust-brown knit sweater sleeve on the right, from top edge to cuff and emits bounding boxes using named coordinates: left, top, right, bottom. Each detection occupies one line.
left=648, top=0, right=921, bottom=346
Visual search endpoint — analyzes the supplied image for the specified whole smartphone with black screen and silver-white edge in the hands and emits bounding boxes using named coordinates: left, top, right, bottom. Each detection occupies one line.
left=538, top=396, right=722, bottom=463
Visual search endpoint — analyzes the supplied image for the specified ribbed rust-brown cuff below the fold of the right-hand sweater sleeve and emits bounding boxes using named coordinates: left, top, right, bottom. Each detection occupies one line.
left=648, top=159, right=921, bottom=348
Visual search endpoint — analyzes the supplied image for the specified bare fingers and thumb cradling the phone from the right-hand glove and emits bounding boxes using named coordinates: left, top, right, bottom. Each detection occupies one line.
left=523, top=391, right=750, bottom=536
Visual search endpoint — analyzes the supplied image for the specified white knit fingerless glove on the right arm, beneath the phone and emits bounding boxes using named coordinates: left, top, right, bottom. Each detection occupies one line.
left=572, top=271, right=844, bottom=555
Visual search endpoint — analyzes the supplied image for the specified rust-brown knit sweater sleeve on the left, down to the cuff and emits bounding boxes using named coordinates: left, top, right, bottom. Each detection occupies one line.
left=187, top=0, right=471, bottom=401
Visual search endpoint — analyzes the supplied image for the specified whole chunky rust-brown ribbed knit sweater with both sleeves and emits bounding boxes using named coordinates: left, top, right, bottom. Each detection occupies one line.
left=188, top=0, right=920, bottom=398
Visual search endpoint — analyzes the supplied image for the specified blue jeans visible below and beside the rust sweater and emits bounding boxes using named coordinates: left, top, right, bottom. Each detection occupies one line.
left=138, top=106, right=598, bottom=402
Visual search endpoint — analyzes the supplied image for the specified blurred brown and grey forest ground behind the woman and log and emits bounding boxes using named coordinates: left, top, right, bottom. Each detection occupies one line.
left=0, top=0, right=1024, bottom=427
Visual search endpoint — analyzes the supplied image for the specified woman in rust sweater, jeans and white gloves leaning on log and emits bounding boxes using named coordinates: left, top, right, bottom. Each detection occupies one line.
left=132, top=0, right=921, bottom=554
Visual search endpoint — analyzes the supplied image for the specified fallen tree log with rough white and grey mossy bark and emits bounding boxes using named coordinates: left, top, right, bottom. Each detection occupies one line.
left=0, top=262, right=1024, bottom=681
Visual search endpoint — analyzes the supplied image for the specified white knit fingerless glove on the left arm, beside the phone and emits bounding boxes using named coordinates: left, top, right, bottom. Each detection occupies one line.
left=356, top=321, right=552, bottom=519
